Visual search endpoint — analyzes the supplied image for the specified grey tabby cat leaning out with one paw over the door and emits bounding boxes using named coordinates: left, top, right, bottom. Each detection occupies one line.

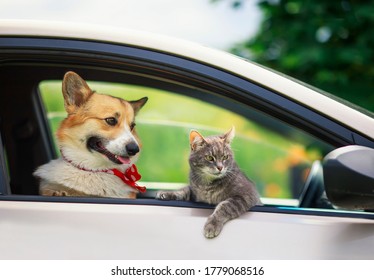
left=156, top=127, right=261, bottom=238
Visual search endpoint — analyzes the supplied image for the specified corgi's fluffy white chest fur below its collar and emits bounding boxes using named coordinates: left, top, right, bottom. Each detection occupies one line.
left=34, top=158, right=137, bottom=198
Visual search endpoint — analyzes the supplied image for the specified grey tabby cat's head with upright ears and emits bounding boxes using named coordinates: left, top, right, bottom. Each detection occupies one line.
left=190, top=127, right=235, bottom=180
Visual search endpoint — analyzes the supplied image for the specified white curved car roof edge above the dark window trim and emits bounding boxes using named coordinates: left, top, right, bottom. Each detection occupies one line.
left=0, top=20, right=374, bottom=139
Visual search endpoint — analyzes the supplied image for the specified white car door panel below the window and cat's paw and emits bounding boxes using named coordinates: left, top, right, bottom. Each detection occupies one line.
left=0, top=201, right=374, bottom=260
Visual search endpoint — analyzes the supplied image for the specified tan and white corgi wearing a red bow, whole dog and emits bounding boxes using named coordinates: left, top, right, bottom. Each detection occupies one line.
left=34, top=72, right=148, bottom=198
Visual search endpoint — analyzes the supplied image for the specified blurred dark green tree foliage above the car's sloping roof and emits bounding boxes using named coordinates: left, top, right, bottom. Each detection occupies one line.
left=212, top=0, right=374, bottom=111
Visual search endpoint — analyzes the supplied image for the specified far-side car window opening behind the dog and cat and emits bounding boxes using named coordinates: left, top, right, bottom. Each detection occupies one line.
left=39, top=81, right=334, bottom=206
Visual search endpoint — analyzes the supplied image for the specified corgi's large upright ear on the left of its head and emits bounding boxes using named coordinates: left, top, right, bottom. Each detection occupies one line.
left=62, top=71, right=93, bottom=114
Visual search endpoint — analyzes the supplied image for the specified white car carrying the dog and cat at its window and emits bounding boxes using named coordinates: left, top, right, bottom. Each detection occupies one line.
left=0, top=21, right=374, bottom=260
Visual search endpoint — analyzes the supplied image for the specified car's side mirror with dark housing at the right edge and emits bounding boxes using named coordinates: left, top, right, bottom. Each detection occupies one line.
left=323, top=145, right=374, bottom=210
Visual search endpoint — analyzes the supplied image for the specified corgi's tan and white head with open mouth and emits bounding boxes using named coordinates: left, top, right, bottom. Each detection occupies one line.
left=57, top=72, right=148, bottom=170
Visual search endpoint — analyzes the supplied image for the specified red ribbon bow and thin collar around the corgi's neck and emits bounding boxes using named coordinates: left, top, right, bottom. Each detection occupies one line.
left=61, top=152, right=147, bottom=193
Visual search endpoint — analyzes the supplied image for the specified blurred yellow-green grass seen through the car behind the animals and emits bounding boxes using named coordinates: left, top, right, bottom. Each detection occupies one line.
left=40, top=81, right=318, bottom=198
